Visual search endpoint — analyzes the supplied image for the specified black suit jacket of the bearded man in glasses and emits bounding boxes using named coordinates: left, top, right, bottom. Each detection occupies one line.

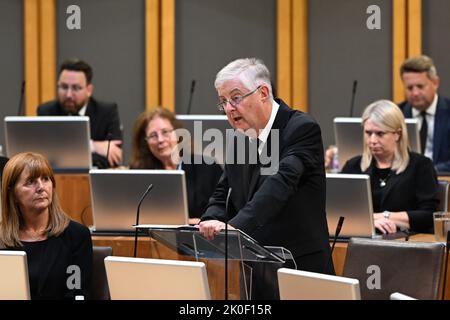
left=37, top=97, right=122, bottom=168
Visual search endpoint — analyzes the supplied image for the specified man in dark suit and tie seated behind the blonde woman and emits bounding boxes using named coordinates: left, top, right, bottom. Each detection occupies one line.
left=399, top=55, right=450, bottom=172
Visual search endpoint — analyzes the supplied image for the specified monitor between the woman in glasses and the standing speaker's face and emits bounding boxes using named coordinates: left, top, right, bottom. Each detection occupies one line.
left=176, top=114, right=234, bottom=165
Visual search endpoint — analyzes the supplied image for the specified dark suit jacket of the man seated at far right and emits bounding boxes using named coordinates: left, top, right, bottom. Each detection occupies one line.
left=399, top=96, right=450, bottom=172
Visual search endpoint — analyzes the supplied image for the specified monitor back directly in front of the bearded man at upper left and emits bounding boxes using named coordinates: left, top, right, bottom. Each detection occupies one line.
left=4, top=116, right=92, bottom=172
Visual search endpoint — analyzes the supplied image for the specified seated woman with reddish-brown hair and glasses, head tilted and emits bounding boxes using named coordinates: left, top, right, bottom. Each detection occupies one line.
left=130, top=108, right=222, bottom=224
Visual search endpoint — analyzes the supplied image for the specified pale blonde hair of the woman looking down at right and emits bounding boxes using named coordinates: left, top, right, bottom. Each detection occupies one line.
left=361, top=100, right=409, bottom=174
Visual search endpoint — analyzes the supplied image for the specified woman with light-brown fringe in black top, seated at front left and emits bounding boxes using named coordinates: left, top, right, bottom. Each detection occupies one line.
left=0, top=153, right=92, bottom=299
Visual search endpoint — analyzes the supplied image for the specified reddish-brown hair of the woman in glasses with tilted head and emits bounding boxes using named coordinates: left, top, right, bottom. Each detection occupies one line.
left=130, top=107, right=183, bottom=169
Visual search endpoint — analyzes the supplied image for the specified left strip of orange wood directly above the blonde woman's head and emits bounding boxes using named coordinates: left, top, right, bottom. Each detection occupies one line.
left=392, top=0, right=407, bottom=103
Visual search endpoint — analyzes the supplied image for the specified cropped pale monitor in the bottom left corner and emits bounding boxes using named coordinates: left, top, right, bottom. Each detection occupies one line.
left=0, top=250, right=31, bottom=300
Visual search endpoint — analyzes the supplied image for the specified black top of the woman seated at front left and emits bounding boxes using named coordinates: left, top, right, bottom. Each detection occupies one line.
left=12, top=221, right=92, bottom=300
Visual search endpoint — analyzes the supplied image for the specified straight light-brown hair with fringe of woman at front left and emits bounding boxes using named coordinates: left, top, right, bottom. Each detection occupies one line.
left=0, top=152, right=70, bottom=248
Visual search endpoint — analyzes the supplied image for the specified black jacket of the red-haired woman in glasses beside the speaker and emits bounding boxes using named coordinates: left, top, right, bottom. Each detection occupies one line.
left=182, top=159, right=222, bottom=218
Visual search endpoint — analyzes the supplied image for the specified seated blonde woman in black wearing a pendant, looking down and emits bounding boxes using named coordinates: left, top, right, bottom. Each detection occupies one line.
left=342, top=100, right=439, bottom=234
